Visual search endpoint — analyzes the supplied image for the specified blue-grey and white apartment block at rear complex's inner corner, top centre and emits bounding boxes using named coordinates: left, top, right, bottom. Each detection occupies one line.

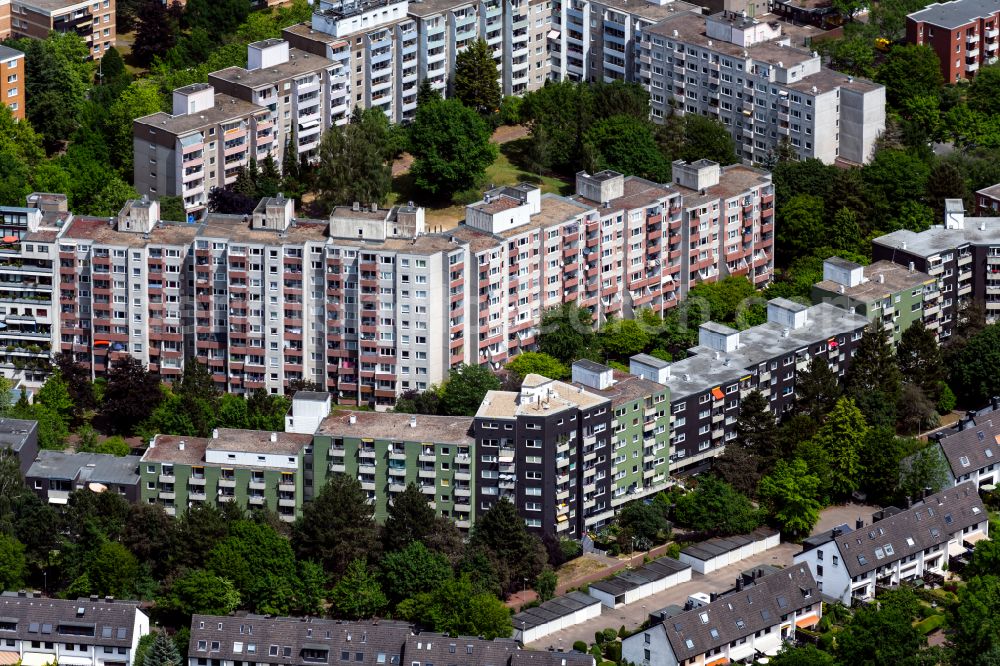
left=549, top=0, right=701, bottom=83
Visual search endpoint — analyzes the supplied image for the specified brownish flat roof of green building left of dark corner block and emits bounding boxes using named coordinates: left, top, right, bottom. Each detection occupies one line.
left=316, top=410, right=476, bottom=446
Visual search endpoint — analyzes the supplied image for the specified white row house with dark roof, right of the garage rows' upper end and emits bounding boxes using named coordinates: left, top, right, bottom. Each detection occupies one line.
left=794, top=482, right=989, bottom=605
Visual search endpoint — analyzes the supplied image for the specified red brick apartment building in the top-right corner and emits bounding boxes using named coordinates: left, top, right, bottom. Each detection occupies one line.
left=906, top=0, right=1000, bottom=83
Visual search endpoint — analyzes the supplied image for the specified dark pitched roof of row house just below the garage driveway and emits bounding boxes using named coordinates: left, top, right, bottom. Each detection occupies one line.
left=660, top=564, right=820, bottom=662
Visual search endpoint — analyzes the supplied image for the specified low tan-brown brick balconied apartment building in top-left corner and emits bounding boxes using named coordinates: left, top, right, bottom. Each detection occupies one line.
left=7, top=0, right=116, bottom=60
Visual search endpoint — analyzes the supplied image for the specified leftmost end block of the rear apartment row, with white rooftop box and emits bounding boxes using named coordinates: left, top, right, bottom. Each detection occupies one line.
left=132, top=83, right=277, bottom=214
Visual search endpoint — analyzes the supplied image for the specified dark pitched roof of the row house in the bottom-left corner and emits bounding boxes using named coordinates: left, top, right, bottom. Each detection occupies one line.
left=0, top=592, right=146, bottom=647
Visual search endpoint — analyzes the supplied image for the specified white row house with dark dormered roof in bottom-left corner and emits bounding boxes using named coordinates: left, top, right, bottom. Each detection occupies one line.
left=0, top=591, right=149, bottom=666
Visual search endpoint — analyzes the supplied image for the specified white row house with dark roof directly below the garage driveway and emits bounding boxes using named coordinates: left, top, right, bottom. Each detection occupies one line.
left=622, top=565, right=823, bottom=666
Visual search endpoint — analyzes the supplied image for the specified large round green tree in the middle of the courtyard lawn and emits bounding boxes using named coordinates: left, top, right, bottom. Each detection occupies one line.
left=410, top=99, right=497, bottom=196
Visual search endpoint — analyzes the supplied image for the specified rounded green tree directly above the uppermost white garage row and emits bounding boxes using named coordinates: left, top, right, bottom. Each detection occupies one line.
left=673, top=476, right=761, bottom=536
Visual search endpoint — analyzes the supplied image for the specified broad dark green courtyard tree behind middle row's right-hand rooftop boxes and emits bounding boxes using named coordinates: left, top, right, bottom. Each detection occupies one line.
left=583, top=115, right=670, bottom=183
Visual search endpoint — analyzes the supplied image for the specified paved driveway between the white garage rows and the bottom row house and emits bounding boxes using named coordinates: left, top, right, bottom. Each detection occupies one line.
left=529, top=543, right=800, bottom=650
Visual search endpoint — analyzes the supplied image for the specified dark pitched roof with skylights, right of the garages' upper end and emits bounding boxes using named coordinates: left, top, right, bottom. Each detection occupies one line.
left=834, top=481, right=987, bottom=577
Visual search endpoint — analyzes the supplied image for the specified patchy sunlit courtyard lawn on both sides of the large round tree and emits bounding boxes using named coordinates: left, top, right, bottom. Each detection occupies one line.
left=389, top=139, right=573, bottom=230
